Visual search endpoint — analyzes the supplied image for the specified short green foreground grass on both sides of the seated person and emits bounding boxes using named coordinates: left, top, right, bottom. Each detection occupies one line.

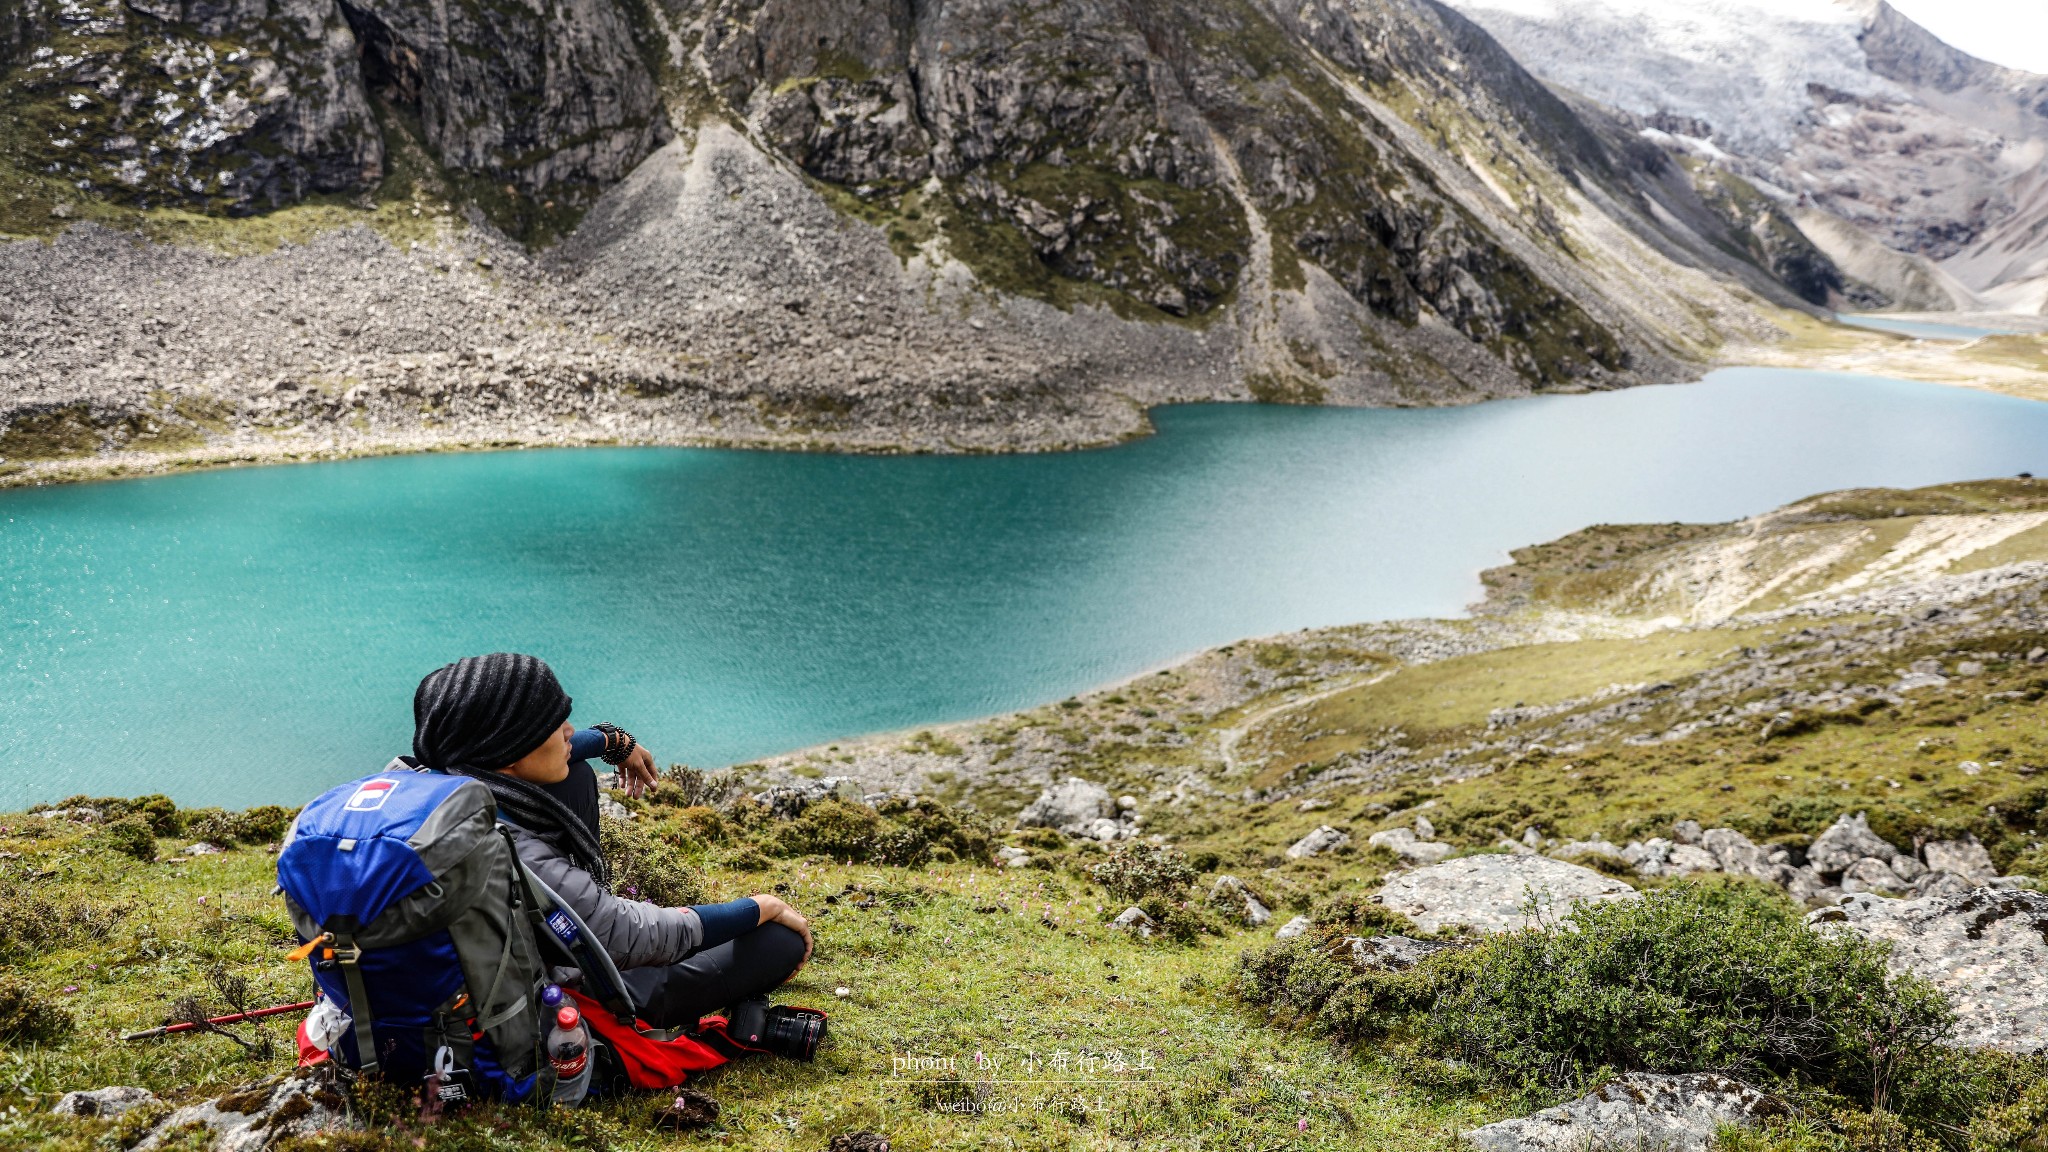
left=0, top=818, right=1495, bottom=1150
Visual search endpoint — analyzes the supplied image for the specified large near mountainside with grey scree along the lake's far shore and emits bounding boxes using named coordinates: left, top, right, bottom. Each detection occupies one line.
left=0, top=0, right=1843, bottom=480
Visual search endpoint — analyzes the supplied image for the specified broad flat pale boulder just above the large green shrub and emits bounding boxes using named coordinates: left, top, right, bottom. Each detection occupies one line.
left=1380, top=855, right=1636, bottom=933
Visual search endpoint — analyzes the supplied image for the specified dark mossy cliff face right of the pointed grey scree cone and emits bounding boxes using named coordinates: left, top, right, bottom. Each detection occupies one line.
left=672, top=0, right=1628, bottom=383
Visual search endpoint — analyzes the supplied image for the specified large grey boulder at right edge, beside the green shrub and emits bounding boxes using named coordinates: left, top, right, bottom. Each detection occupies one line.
left=1806, top=888, right=2048, bottom=1052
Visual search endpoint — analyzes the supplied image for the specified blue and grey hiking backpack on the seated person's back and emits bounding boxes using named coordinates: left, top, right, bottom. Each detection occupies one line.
left=276, top=760, right=633, bottom=1103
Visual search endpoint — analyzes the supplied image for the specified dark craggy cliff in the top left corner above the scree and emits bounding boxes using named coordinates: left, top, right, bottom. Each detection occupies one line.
left=0, top=0, right=668, bottom=213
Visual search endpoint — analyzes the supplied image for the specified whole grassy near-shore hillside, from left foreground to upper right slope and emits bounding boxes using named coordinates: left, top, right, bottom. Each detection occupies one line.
left=0, top=482, right=2048, bottom=1152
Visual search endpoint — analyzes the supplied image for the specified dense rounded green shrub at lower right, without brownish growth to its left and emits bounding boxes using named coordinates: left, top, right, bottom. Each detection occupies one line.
left=1427, top=883, right=1954, bottom=1107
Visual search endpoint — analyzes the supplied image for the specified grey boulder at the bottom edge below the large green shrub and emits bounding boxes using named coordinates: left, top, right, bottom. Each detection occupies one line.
left=1462, top=1072, right=1782, bottom=1152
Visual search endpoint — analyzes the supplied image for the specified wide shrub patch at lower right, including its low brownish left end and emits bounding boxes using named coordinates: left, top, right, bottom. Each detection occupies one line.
left=1237, top=881, right=1989, bottom=1132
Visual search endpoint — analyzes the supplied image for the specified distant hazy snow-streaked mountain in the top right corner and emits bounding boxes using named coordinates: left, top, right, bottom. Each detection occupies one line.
left=1452, top=0, right=2048, bottom=312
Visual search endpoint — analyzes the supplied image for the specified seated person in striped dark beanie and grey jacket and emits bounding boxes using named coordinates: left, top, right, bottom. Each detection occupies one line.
left=412, top=652, right=811, bottom=1027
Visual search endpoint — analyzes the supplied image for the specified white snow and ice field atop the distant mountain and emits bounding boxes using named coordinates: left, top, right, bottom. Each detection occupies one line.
left=1448, top=0, right=1896, bottom=154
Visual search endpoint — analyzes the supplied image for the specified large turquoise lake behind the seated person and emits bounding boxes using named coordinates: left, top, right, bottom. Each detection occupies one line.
left=0, top=369, right=2048, bottom=808
